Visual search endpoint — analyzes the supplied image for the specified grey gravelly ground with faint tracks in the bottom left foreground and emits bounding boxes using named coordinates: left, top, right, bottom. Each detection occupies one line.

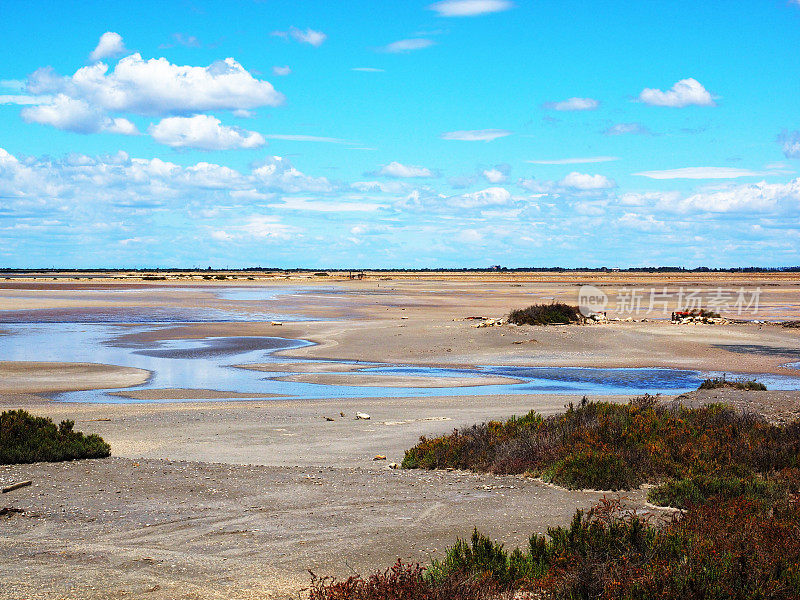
left=0, top=458, right=624, bottom=600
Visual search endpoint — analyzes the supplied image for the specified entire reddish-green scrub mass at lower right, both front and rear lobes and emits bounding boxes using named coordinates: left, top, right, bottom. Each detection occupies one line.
left=310, top=396, right=800, bottom=600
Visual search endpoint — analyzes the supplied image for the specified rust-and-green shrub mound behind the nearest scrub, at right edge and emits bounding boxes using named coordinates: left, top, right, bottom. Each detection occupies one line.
left=402, top=396, right=800, bottom=490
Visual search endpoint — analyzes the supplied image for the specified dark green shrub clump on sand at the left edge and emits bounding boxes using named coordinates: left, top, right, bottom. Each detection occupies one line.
left=0, top=410, right=111, bottom=465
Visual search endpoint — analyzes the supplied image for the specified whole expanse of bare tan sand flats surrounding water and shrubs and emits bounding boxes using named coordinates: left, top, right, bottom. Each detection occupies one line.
left=0, top=273, right=800, bottom=600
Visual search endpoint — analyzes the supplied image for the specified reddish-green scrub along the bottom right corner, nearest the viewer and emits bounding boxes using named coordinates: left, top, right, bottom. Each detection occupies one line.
left=310, top=498, right=800, bottom=600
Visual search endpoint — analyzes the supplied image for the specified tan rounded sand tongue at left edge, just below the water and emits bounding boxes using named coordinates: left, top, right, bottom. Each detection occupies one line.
left=0, top=361, right=150, bottom=394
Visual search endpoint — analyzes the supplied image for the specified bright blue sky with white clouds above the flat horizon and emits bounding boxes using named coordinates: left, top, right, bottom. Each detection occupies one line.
left=0, top=0, right=800, bottom=267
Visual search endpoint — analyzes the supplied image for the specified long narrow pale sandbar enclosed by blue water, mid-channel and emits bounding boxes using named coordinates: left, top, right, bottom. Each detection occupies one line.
left=276, top=373, right=522, bottom=388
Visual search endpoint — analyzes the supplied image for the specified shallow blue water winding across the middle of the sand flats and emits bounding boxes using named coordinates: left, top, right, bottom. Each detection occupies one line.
left=0, top=322, right=800, bottom=403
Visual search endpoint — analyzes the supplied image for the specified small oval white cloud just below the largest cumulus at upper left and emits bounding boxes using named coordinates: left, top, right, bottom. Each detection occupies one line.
left=148, top=115, right=266, bottom=150
